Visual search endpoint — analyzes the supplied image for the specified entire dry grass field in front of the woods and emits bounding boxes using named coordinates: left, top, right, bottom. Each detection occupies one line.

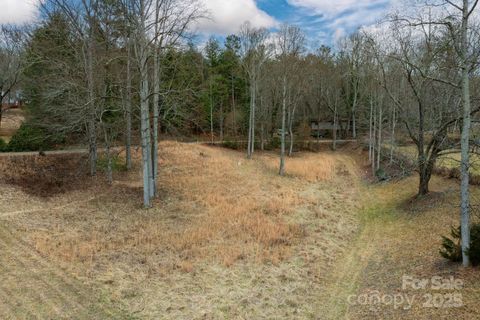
left=0, top=142, right=480, bottom=319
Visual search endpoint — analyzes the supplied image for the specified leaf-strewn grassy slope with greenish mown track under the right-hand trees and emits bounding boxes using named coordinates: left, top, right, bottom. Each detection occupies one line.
left=345, top=176, right=480, bottom=319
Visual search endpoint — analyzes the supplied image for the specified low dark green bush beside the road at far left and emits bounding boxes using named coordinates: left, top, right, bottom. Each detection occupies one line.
left=7, top=123, right=63, bottom=152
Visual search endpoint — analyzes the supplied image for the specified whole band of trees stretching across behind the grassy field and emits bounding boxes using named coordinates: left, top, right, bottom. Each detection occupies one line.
left=1, top=0, right=480, bottom=264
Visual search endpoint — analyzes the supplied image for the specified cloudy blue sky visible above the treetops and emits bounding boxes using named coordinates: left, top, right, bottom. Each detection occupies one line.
left=0, top=0, right=398, bottom=46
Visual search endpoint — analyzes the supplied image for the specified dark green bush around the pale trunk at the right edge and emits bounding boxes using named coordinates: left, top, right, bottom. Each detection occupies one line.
left=440, top=224, right=480, bottom=265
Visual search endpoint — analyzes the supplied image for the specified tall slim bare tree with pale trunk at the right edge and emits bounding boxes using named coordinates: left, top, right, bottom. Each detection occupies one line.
left=386, top=0, right=479, bottom=266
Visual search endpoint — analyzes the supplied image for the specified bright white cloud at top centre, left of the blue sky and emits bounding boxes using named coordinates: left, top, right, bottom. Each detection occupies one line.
left=196, top=0, right=278, bottom=35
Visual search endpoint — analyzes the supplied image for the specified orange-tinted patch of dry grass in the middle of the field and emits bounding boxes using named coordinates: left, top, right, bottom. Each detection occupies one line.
left=25, top=142, right=342, bottom=266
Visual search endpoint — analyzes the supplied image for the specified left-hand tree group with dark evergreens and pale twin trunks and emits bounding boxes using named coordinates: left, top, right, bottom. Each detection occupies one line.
left=18, top=0, right=202, bottom=207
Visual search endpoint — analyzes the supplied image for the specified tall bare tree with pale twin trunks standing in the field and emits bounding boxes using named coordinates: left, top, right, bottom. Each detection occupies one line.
left=128, top=0, right=200, bottom=207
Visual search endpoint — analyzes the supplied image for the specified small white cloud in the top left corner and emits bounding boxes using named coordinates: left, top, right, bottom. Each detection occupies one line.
left=0, top=0, right=39, bottom=24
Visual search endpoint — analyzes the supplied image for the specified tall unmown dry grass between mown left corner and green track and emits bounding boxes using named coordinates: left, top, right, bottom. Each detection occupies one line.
left=2, top=142, right=358, bottom=319
